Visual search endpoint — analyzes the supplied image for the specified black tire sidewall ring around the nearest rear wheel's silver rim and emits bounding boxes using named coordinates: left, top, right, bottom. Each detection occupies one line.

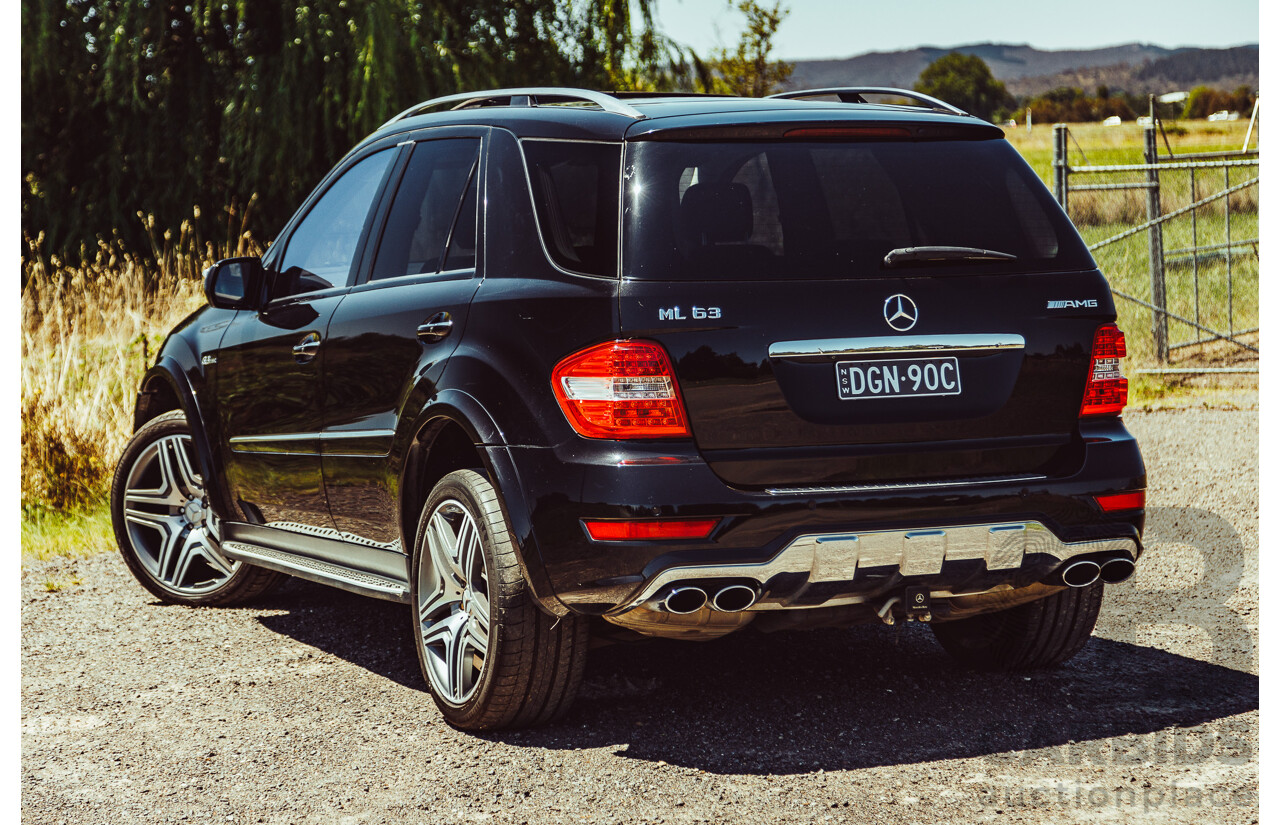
left=410, top=469, right=504, bottom=727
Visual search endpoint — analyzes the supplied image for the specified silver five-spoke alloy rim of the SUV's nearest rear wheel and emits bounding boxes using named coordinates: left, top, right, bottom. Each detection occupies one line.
left=416, top=499, right=490, bottom=706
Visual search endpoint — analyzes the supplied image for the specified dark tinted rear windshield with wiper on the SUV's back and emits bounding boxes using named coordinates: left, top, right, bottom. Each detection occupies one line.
left=623, top=141, right=1093, bottom=280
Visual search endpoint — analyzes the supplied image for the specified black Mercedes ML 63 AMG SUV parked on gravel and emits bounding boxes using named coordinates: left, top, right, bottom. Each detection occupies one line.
left=111, top=88, right=1146, bottom=728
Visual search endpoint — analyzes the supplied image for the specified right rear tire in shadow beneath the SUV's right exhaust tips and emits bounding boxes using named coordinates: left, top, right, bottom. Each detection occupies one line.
left=931, top=582, right=1102, bottom=670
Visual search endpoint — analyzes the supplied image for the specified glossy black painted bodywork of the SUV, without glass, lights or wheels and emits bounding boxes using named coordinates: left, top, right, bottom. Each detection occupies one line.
left=137, top=93, right=1146, bottom=613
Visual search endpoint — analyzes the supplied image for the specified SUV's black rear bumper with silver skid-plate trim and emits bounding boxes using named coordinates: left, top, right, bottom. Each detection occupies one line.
left=503, top=420, right=1146, bottom=615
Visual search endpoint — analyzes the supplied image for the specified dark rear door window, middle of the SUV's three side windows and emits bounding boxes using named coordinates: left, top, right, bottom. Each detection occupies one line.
left=370, top=138, right=480, bottom=280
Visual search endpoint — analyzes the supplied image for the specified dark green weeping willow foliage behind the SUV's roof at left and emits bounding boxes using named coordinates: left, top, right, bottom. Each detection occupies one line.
left=22, top=0, right=692, bottom=257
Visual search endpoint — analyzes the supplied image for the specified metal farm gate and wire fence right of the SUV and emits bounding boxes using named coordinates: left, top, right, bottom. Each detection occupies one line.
left=1053, top=122, right=1261, bottom=372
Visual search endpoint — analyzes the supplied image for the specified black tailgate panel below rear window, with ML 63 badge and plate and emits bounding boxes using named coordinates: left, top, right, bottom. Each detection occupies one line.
left=621, top=271, right=1115, bottom=487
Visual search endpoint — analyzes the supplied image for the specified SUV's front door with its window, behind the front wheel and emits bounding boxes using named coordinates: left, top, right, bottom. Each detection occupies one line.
left=215, top=147, right=397, bottom=533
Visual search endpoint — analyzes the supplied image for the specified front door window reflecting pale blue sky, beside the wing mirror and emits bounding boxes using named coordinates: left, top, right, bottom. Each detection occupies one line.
left=271, top=148, right=396, bottom=298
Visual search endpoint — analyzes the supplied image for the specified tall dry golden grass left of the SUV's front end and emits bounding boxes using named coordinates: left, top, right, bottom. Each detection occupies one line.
left=22, top=211, right=257, bottom=526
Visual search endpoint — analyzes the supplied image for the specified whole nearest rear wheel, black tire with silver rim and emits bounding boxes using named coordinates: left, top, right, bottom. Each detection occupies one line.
left=410, top=469, right=589, bottom=730
